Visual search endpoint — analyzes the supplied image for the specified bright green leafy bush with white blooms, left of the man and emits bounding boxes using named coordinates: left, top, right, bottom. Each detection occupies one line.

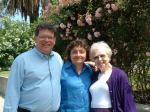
left=0, top=17, right=34, bottom=68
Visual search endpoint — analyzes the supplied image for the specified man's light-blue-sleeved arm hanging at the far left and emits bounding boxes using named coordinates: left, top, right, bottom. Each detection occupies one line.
left=3, top=58, right=24, bottom=112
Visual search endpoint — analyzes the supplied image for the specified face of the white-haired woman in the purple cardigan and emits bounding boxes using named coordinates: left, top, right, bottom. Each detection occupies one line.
left=93, top=49, right=110, bottom=71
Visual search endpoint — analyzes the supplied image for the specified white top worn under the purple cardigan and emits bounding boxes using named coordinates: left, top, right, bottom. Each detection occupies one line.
left=90, top=71, right=112, bottom=108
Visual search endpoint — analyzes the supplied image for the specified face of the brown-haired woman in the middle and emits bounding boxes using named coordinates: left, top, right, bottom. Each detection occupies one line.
left=70, top=46, right=87, bottom=65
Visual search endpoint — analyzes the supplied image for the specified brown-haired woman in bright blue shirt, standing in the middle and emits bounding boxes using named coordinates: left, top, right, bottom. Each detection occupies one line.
left=60, top=39, right=93, bottom=112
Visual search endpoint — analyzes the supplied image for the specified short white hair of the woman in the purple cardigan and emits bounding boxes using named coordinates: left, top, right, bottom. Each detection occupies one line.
left=90, top=41, right=112, bottom=59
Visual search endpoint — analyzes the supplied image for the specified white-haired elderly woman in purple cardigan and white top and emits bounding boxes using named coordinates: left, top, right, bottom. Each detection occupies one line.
left=90, top=41, right=136, bottom=112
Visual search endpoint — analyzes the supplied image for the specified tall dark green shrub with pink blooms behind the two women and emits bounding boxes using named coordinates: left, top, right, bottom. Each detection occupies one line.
left=46, top=0, right=150, bottom=102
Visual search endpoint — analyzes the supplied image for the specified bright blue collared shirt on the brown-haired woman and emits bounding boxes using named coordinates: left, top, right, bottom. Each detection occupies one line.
left=60, top=61, right=93, bottom=112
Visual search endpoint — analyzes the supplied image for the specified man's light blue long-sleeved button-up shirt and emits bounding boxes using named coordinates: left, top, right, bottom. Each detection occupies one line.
left=4, top=48, right=63, bottom=112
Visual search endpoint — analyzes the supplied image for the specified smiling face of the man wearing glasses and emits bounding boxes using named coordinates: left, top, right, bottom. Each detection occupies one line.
left=35, top=29, right=56, bottom=55
